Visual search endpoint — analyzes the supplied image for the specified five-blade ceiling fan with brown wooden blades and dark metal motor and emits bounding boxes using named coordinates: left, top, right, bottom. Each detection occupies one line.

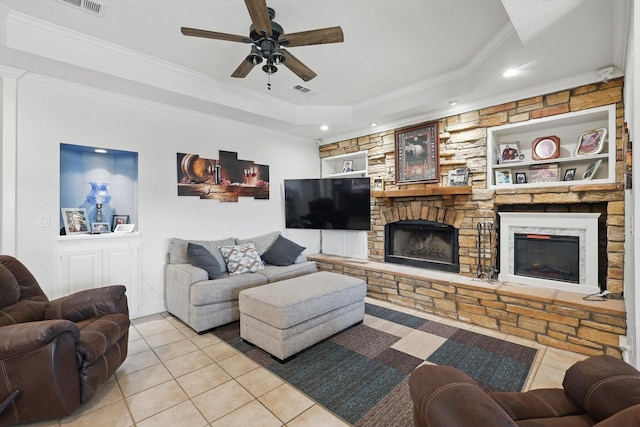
left=181, top=0, right=344, bottom=84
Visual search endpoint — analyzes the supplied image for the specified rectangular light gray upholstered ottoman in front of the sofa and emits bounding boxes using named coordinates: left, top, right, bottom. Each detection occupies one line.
left=239, top=271, right=367, bottom=361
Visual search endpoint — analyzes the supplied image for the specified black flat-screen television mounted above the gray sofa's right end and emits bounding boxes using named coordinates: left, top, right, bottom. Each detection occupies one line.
left=284, top=178, right=371, bottom=230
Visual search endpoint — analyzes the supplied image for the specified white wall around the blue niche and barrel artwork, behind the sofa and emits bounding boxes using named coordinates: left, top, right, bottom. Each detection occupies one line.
left=10, top=73, right=320, bottom=315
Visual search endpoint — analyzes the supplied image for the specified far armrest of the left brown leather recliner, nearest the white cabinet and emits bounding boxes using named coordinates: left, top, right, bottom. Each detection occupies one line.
left=44, top=285, right=129, bottom=322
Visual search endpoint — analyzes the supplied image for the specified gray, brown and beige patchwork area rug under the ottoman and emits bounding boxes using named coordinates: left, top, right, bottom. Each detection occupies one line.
left=212, top=303, right=537, bottom=427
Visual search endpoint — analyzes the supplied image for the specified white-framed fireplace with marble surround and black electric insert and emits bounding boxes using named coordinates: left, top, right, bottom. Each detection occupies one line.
left=498, top=212, right=600, bottom=294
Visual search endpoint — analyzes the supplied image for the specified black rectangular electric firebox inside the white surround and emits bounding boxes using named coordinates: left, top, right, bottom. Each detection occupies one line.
left=514, top=233, right=580, bottom=283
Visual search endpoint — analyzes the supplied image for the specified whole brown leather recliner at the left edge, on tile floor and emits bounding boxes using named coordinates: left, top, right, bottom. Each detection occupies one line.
left=0, top=255, right=130, bottom=426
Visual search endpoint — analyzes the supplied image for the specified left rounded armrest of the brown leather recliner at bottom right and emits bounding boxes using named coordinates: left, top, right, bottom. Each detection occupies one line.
left=409, top=365, right=517, bottom=427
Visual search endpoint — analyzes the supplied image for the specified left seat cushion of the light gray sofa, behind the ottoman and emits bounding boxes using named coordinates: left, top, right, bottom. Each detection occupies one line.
left=190, top=274, right=267, bottom=306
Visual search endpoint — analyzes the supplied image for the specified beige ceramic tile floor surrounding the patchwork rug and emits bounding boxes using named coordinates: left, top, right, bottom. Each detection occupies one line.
left=25, top=298, right=586, bottom=427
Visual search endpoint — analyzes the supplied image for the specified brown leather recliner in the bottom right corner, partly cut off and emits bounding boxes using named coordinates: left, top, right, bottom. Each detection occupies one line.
left=409, top=356, right=640, bottom=427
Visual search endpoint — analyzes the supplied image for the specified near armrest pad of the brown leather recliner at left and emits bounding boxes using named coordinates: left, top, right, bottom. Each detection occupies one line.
left=0, top=320, right=80, bottom=360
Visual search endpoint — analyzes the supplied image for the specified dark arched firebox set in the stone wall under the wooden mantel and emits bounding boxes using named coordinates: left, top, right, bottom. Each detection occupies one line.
left=384, top=220, right=460, bottom=273
